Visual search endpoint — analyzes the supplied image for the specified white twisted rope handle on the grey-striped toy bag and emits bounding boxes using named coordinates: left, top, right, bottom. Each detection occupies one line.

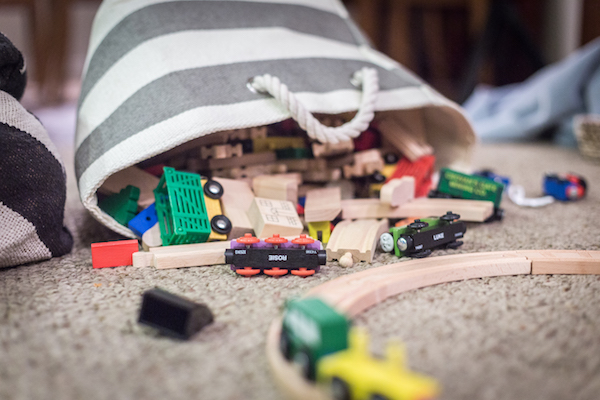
left=248, top=67, right=379, bottom=143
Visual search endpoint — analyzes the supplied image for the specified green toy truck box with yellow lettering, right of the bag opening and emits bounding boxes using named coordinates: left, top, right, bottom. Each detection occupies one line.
left=429, top=168, right=504, bottom=220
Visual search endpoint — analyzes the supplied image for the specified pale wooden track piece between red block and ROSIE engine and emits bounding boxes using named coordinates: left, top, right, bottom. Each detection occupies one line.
left=150, top=241, right=230, bottom=269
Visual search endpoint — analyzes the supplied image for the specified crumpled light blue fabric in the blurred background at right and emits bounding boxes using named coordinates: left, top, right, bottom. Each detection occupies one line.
left=464, top=38, right=600, bottom=145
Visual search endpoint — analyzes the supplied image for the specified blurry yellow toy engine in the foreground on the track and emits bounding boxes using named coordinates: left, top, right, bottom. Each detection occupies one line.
left=316, top=328, right=440, bottom=400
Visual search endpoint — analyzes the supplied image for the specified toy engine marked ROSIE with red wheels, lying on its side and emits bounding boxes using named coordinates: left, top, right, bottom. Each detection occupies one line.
left=225, top=234, right=327, bottom=276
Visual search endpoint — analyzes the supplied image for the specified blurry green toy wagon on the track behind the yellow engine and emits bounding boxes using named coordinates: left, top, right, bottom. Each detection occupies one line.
left=280, top=297, right=350, bottom=380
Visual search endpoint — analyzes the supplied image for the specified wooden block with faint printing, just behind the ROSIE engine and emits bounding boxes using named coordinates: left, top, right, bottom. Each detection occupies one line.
left=248, top=197, right=304, bottom=238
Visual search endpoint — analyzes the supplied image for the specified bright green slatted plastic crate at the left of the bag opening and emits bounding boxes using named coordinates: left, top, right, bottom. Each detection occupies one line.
left=154, top=167, right=211, bottom=246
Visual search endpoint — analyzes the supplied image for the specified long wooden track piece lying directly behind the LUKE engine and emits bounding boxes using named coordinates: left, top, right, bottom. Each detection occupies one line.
left=342, top=197, right=494, bottom=222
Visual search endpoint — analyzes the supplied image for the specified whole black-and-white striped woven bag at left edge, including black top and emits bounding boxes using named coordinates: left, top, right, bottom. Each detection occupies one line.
left=0, top=34, right=73, bottom=267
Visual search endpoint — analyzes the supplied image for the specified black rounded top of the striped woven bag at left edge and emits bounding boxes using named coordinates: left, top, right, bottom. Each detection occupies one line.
left=0, top=33, right=27, bottom=100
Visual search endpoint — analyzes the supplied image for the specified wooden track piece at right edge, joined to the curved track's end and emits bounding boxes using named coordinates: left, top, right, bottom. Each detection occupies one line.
left=517, top=250, right=600, bottom=274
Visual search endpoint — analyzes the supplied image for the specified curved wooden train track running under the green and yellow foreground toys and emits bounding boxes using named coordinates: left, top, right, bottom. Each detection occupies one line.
left=266, top=250, right=600, bottom=400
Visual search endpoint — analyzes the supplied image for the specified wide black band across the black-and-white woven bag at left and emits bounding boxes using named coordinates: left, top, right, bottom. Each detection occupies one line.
left=0, top=123, right=73, bottom=257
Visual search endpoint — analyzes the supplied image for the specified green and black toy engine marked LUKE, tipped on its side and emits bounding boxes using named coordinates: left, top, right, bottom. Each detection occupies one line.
left=379, top=211, right=467, bottom=258
